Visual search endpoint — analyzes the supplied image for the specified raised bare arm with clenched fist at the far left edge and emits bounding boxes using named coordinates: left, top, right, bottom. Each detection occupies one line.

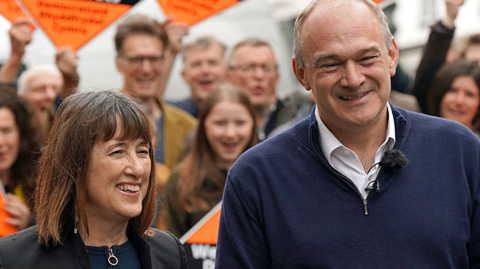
left=0, top=19, right=33, bottom=84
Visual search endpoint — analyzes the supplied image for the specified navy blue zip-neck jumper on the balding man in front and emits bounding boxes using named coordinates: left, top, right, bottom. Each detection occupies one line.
left=216, top=106, right=480, bottom=269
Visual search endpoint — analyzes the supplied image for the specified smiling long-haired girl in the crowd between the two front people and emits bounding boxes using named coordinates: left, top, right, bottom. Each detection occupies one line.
left=159, top=84, right=257, bottom=237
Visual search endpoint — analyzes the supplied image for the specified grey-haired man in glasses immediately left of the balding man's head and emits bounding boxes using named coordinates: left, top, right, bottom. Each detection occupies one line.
left=227, top=38, right=308, bottom=141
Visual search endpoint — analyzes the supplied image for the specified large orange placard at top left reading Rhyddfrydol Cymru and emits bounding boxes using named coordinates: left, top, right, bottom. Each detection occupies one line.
left=17, top=0, right=139, bottom=50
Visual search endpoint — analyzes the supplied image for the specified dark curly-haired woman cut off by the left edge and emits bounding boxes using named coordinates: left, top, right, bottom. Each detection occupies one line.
left=0, top=86, right=41, bottom=232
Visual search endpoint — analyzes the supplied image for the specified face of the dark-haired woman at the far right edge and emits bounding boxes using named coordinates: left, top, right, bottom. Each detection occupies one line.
left=440, top=76, right=480, bottom=128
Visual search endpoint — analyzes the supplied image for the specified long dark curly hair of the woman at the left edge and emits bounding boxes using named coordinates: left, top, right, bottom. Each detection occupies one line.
left=0, top=85, right=41, bottom=205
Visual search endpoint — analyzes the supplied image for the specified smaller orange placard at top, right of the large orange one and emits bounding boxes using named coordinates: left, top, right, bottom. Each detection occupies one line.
left=157, top=0, right=239, bottom=25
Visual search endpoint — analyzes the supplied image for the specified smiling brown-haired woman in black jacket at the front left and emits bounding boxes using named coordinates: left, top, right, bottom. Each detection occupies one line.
left=0, top=91, right=186, bottom=268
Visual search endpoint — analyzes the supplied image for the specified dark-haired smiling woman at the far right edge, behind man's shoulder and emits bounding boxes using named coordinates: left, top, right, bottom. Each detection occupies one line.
left=428, top=60, right=480, bottom=135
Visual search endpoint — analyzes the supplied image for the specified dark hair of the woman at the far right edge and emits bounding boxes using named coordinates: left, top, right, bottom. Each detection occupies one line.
left=428, top=60, right=480, bottom=129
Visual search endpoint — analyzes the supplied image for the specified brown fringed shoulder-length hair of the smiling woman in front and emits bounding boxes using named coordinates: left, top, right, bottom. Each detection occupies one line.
left=35, top=91, right=156, bottom=247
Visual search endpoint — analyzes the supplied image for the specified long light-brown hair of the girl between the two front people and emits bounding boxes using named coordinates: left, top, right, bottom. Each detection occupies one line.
left=172, top=83, right=257, bottom=212
